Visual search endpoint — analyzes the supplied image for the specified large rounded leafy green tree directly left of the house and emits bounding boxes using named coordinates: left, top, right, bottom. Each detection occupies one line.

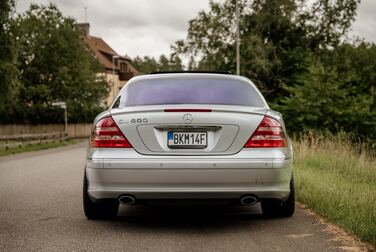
left=14, top=4, right=108, bottom=108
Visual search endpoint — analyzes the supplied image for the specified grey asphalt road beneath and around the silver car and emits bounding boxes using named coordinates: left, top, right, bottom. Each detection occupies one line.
left=0, top=144, right=366, bottom=252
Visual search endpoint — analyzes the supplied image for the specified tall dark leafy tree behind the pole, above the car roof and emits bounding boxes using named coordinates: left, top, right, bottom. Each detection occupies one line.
left=173, top=0, right=359, bottom=101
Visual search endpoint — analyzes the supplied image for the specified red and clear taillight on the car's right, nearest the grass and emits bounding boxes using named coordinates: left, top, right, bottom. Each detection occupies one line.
left=244, top=116, right=286, bottom=148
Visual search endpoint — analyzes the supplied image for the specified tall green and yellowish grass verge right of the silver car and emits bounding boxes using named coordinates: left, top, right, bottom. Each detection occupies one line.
left=293, top=139, right=376, bottom=245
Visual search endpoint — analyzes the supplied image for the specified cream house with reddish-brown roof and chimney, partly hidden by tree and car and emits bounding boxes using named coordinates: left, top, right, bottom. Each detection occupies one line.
left=78, top=23, right=138, bottom=106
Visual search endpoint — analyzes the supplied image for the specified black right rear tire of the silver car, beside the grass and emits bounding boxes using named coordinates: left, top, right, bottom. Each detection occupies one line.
left=261, top=177, right=295, bottom=217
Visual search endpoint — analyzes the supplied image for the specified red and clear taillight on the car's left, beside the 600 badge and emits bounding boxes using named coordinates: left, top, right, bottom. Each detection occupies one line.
left=91, top=116, right=132, bottom=148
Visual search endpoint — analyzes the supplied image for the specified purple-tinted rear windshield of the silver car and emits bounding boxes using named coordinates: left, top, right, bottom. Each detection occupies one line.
left=120, top=77, right=266, bottom=108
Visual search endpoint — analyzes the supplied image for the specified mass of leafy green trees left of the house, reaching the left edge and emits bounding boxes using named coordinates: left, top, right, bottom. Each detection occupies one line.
left=0, top=1, right=109, bottom=124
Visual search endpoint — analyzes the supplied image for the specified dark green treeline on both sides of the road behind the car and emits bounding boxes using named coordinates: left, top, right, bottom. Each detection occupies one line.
left=0, top=0, right=376, bottom=141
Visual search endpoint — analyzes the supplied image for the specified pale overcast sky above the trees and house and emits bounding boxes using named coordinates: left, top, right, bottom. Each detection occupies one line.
left=16, top=0, right=376, bottom=57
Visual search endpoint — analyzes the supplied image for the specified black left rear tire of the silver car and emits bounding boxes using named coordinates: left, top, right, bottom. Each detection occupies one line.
left=83, top=174, right=119, bottom=220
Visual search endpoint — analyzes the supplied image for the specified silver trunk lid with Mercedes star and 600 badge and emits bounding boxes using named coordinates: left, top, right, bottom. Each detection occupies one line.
left=111, top=105, right=268, bottom=155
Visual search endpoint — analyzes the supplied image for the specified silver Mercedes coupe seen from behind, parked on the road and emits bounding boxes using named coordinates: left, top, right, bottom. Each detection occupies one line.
left=83, top=73, right=295, bottom=219
